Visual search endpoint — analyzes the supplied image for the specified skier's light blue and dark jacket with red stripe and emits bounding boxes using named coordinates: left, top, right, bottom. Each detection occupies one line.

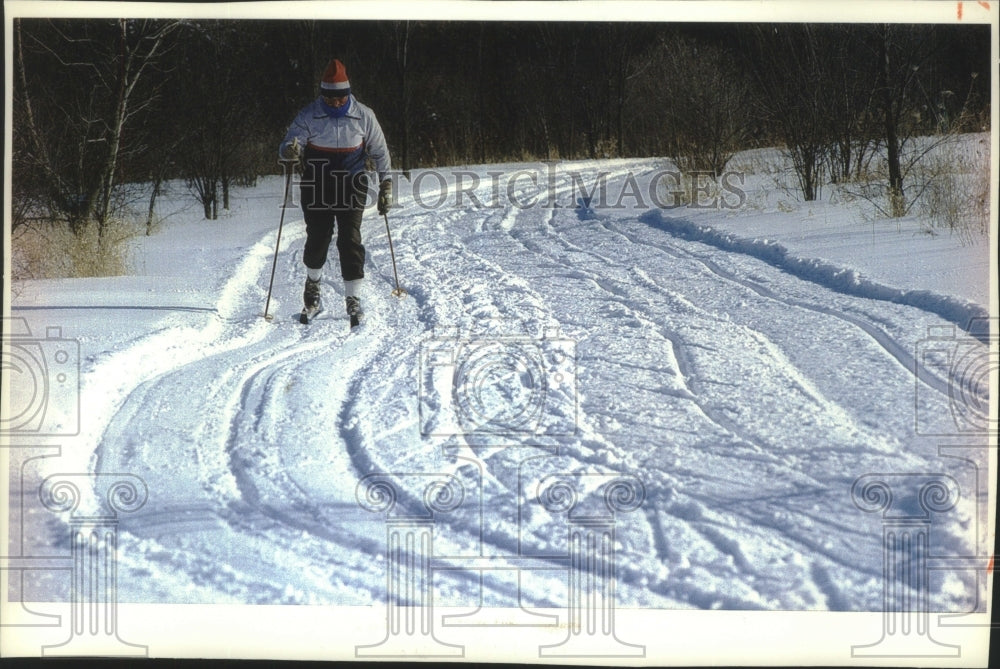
left=278, top=95, right=392, bottom=206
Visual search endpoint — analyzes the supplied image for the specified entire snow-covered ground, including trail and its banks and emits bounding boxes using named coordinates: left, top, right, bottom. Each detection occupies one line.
left=10, top=153, right=996, bottom=632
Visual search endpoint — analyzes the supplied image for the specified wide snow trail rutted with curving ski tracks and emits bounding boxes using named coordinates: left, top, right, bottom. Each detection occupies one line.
left=48, top=162, right=975, bottom=610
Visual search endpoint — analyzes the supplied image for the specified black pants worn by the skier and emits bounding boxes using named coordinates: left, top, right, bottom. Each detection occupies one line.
left=302, top=207, right=365, bottom=281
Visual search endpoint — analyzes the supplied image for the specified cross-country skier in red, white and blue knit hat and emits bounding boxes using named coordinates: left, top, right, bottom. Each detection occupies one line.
left=279, top=59, right=392, bottom=327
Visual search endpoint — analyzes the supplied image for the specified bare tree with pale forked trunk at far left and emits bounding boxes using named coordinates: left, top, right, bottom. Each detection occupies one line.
left=16, top=19, right=180, bottom=239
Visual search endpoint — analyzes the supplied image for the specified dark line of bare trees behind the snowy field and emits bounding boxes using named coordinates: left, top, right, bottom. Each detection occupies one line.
left=12, top=19, right=990, bottom=229
